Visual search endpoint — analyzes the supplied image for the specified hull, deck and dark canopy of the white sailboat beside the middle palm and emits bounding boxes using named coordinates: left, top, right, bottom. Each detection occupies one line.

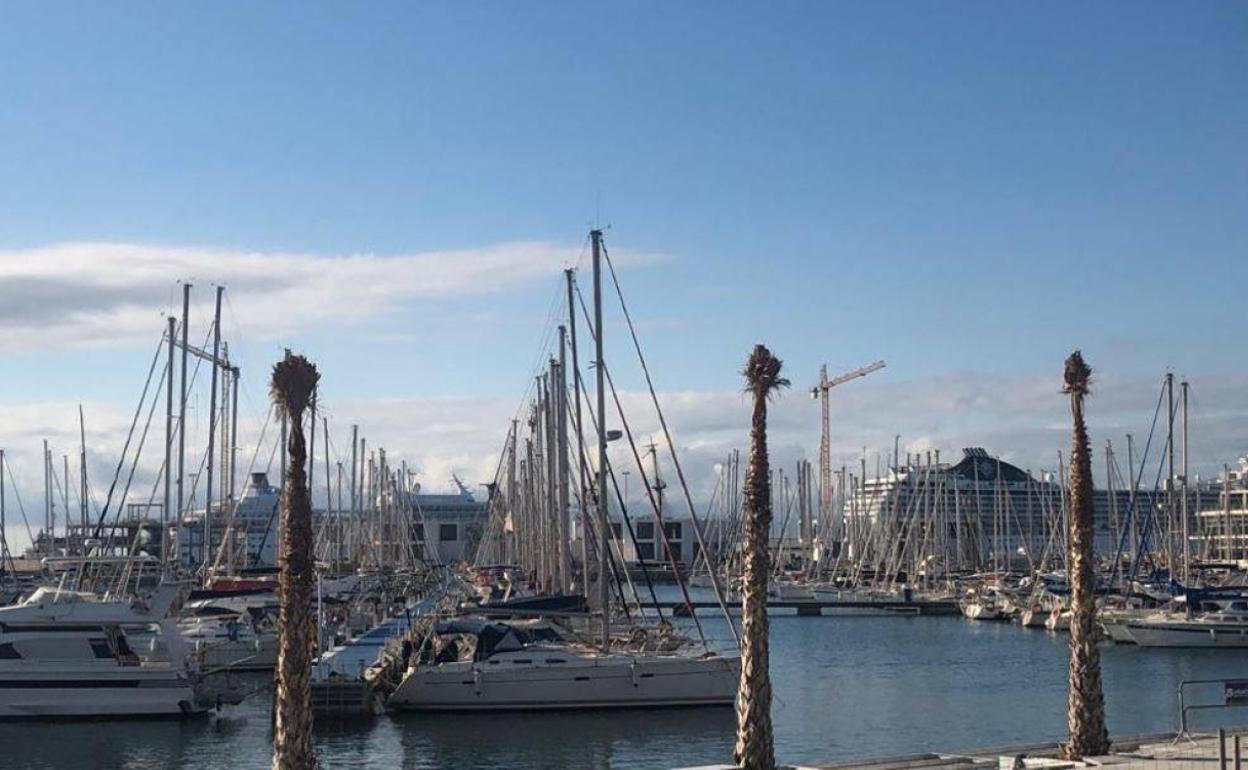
left=387, top=619, right=741, bottom=711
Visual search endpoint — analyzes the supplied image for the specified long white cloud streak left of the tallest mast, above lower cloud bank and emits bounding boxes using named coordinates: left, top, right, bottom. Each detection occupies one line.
left=0, top=241, right=660, bottom=351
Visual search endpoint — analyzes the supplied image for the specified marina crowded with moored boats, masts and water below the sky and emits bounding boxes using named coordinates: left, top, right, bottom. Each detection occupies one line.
left=0, top=230, right=1248, bottom=769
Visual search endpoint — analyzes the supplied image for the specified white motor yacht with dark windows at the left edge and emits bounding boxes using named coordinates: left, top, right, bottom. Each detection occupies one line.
left=0, top=585, right=211, bottom=719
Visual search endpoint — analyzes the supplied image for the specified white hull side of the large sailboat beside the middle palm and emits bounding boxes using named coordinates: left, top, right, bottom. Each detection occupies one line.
left=387, top=650, right=740, bottom=711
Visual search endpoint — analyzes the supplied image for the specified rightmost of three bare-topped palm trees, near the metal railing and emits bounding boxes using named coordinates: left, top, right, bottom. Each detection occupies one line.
left=1062, top=351, right=1109, bottom=760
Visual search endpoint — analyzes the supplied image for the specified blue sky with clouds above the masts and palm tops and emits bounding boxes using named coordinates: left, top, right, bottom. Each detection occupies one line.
left=0, top=1, right=1248, bottom=549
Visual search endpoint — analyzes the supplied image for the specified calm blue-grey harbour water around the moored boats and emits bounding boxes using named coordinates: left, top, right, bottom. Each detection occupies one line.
left=0, top=616, right=1248, bottom=770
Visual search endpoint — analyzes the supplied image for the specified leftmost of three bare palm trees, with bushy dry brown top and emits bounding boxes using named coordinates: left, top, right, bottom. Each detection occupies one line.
left=271, top=352, right=319, bottom=770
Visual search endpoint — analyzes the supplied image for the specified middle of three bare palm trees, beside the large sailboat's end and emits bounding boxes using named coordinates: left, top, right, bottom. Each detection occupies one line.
left=734, top=344, right=787, bottom=770
